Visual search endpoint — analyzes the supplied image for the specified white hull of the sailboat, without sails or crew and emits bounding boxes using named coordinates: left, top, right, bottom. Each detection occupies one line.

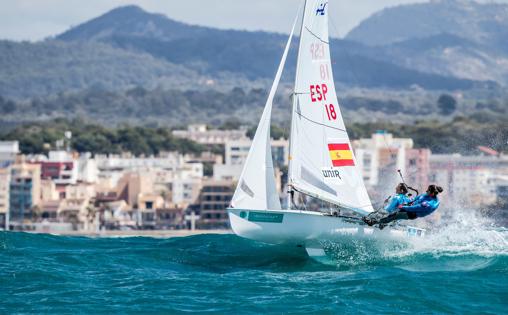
left=228, top=209, right=425, bottom=248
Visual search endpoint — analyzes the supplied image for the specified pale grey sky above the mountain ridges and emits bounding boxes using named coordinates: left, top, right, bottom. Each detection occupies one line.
left=0, top=0, right=508, bottom=41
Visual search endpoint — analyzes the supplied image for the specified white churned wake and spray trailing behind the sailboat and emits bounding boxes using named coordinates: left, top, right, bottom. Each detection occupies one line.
left=323, top=213, right=508, bottom=272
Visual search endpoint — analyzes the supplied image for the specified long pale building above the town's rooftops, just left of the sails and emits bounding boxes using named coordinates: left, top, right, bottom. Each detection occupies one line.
left=173, top=124, right=247, bottom=145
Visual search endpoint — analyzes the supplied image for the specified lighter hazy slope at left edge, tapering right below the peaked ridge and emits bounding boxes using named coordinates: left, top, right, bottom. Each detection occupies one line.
left=0, top=41, right=205, bottom=98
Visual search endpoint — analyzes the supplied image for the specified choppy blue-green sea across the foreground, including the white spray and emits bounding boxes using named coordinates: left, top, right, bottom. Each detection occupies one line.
left=0, top=223, right=508, bottom=314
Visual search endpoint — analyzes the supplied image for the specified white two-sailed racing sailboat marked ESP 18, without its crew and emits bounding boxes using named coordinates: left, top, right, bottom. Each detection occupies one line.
left=227, top=0, right=424, bottom=256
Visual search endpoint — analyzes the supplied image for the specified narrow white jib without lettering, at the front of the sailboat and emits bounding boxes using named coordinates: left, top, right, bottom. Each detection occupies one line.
left=231, top=9, right=298, bottom=210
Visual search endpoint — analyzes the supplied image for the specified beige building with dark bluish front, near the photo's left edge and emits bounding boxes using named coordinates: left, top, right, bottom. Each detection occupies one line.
left=9, top=160, right=41, bottom=229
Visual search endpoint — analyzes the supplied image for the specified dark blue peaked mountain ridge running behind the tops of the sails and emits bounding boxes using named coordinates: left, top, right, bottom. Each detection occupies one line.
left=57, top=6, right=488, bottom=89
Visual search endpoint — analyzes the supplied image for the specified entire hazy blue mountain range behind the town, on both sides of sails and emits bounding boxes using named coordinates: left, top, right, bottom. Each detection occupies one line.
left=0, top=0, right=508, bottom=127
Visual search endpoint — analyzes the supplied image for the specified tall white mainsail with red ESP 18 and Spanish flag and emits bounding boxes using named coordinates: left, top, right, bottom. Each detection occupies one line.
left=289, top=0, right=373, bottom=214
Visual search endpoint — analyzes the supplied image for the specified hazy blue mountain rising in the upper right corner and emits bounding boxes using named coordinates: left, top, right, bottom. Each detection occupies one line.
left=346, top=0, right=508, bottom=84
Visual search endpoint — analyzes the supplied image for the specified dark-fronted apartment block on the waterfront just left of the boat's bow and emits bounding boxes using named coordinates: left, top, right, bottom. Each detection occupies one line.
left=196, top=180, right=234, bottom=229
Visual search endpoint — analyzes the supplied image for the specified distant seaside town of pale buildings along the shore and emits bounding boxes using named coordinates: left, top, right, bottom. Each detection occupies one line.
left=0, top=125, right=508, bottom=235
